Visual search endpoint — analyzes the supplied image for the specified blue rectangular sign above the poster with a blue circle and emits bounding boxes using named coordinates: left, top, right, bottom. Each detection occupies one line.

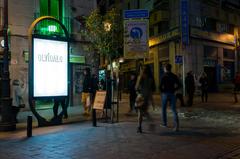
left=123, top=9, right=149, bottom=19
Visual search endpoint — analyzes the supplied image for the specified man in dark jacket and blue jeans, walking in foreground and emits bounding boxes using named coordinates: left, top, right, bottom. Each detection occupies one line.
left=160, top=64, right=180, bottom=131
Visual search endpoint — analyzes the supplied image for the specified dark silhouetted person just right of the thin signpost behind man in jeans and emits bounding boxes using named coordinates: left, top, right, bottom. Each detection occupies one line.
left=185, top=71, right=195, bottom=106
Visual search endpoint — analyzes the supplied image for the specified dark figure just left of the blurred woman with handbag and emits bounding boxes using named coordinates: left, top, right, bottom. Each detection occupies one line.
left=128, top=74, right=137, bottom=113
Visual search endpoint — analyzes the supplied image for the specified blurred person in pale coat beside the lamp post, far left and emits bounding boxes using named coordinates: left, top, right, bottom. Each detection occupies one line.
left=11, top=79, right=24, bottom=123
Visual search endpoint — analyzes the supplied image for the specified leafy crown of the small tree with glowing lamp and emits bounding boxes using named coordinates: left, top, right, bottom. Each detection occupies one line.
left=83, top=8, right=123, bottom=64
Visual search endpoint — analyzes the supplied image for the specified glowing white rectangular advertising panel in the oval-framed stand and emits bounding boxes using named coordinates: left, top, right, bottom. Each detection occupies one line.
left=33, top=38, right=68, bottom=97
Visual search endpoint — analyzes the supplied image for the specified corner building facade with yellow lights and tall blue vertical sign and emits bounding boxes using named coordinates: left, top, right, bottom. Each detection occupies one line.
left=125, top=0, right=240, bottom=91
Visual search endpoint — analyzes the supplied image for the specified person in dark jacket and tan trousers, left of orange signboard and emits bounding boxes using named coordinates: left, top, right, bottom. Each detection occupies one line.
left=82, top=68, right=92, bottom=115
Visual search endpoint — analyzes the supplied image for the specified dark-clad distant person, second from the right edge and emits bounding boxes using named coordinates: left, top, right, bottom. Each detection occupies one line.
left=199, top=72, right=208, bottom=102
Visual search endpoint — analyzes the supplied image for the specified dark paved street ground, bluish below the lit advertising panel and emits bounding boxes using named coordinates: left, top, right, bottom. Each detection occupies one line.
left=0, top=94, right=240, bottom=159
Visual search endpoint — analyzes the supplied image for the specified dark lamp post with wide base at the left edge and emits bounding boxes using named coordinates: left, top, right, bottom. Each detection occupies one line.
left=0, top=0, right=16, bottom=131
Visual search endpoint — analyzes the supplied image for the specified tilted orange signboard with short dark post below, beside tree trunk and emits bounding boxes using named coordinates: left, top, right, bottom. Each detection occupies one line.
left=92, top=91, right=106, bottom=127
